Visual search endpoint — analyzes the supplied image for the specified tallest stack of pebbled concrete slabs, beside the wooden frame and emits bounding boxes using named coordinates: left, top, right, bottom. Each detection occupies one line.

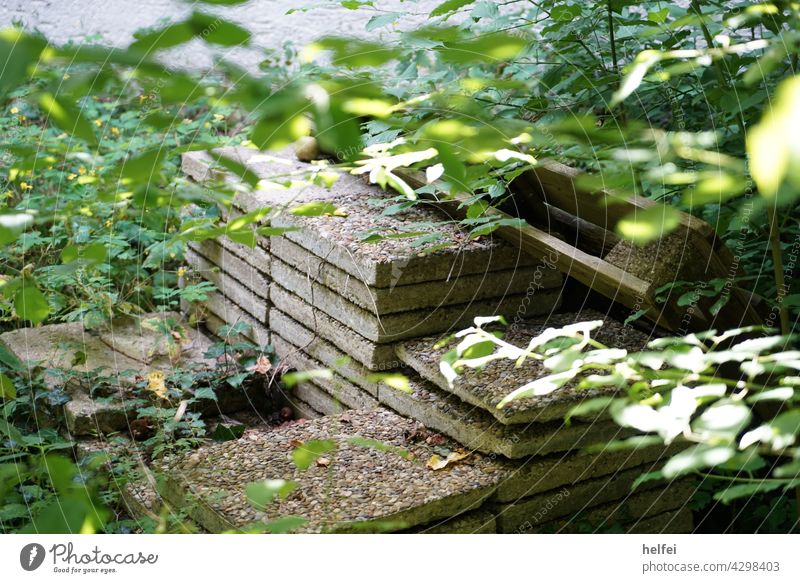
left=183, top=148, right=562, bottom=414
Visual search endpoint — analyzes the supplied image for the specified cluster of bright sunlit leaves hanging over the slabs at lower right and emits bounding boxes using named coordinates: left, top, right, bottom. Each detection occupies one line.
left=441, top=321, right=800, bottom=503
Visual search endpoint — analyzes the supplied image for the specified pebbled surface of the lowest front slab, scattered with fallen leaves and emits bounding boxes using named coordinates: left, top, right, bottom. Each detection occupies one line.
left=162, top=409, right=497, bottom=532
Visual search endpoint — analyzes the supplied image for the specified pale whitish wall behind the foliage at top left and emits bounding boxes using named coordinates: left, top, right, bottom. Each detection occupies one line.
left=0, top=0, right=442, bottom=67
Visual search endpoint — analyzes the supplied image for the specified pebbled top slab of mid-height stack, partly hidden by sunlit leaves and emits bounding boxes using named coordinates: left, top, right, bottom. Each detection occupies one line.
left=395, top=310, right=648, bottom=424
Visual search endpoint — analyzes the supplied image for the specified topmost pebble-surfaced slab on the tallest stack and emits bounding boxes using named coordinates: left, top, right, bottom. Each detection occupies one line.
left=183, top=148, right=541, bottom=288
